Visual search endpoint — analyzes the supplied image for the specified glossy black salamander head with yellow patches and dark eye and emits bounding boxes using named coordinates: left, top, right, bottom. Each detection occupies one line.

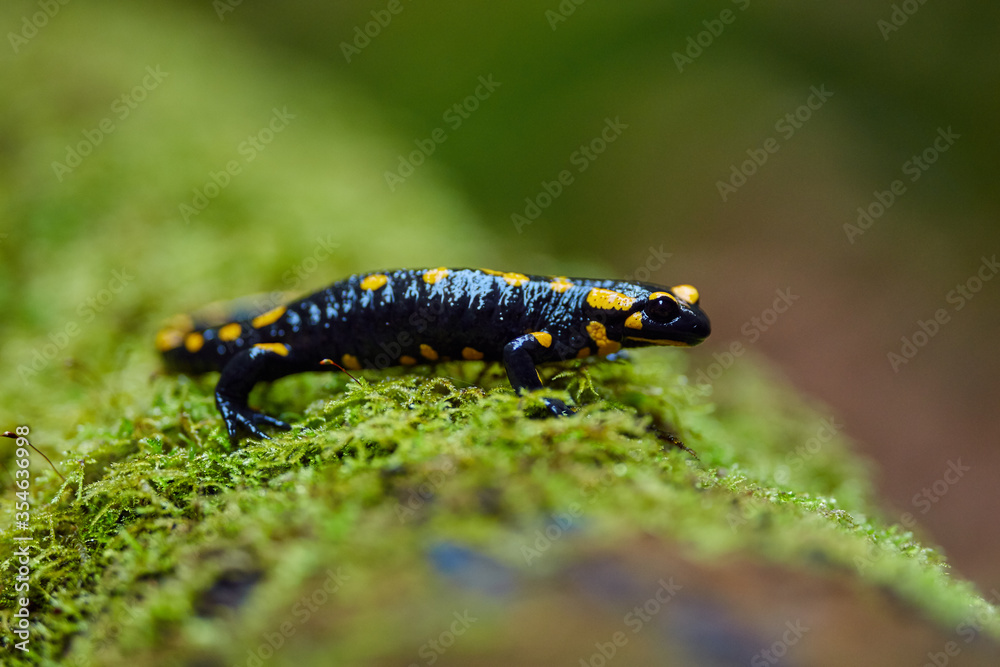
left=622, top=284, right=712, bottom=347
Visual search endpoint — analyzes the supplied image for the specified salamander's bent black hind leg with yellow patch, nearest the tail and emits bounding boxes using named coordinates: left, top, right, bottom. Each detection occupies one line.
left=215, top=343, right=302, bottom=444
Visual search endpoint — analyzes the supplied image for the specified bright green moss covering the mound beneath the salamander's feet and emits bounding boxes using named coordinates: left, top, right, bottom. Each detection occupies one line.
left=0, top=351, right=1000, bottom=664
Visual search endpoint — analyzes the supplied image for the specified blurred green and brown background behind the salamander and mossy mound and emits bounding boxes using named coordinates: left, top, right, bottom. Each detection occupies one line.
left=0, top=0, right=1000, bottom=590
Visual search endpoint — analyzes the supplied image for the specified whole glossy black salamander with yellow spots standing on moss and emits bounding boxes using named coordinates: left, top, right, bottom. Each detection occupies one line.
left=156, top=267, right=710, bottom=442
